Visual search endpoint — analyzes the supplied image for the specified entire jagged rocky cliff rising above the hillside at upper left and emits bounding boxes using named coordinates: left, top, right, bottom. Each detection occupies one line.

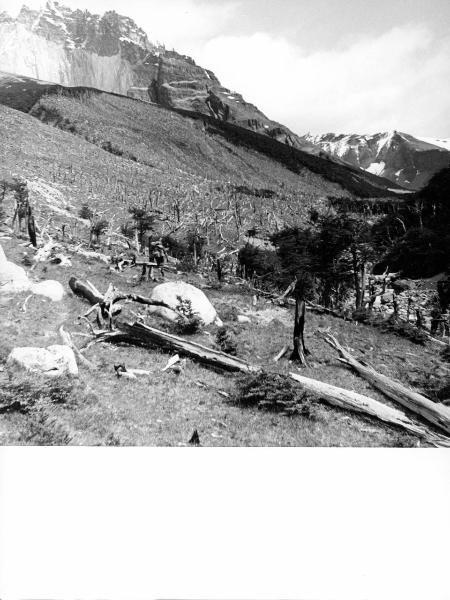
left=0, top=1, right=308, bottom=148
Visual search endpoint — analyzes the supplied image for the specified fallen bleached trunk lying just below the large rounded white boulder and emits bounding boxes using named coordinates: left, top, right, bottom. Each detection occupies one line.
left=93, top=322, right=260, bottom=373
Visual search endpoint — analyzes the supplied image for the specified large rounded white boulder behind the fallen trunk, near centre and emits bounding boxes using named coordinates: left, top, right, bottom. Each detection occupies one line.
left=148, top=281, right=223, bottom=327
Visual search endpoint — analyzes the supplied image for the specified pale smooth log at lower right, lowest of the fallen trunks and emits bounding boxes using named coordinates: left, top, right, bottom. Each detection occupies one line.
left=290, top=373, right=450, bottom=447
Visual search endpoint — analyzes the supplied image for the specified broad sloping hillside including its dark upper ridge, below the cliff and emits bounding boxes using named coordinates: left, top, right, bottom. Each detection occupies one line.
left=0, top=68, right=408, bottom=232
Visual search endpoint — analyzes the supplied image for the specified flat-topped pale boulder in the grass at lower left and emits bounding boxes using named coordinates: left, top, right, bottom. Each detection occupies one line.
left=6, top=345, right=78, bottom=377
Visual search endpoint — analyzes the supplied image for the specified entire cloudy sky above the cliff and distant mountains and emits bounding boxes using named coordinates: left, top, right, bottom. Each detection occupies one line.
left=0, top=0, right=450, bottom=138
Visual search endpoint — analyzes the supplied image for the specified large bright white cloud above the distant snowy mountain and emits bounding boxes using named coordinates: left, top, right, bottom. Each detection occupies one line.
left=198, top=27, right=450, bottom=136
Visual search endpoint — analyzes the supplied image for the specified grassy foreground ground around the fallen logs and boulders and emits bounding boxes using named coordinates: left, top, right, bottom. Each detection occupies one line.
left=0, top=230, right=446, bottom=446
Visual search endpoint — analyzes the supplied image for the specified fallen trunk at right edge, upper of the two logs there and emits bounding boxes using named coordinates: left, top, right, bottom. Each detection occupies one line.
left=324, top=334, right=450, bottom=434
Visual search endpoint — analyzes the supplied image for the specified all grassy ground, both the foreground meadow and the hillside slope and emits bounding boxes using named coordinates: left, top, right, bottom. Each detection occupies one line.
left=0, top=81, right=441, bottom=446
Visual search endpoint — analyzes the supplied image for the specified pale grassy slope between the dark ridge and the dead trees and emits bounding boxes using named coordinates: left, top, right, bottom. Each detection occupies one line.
left=0, top=94, right=347, bottom=240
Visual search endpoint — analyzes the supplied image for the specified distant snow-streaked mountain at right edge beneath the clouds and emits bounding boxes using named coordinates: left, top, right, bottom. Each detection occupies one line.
left=303, top=131, right=450, bottom=189
